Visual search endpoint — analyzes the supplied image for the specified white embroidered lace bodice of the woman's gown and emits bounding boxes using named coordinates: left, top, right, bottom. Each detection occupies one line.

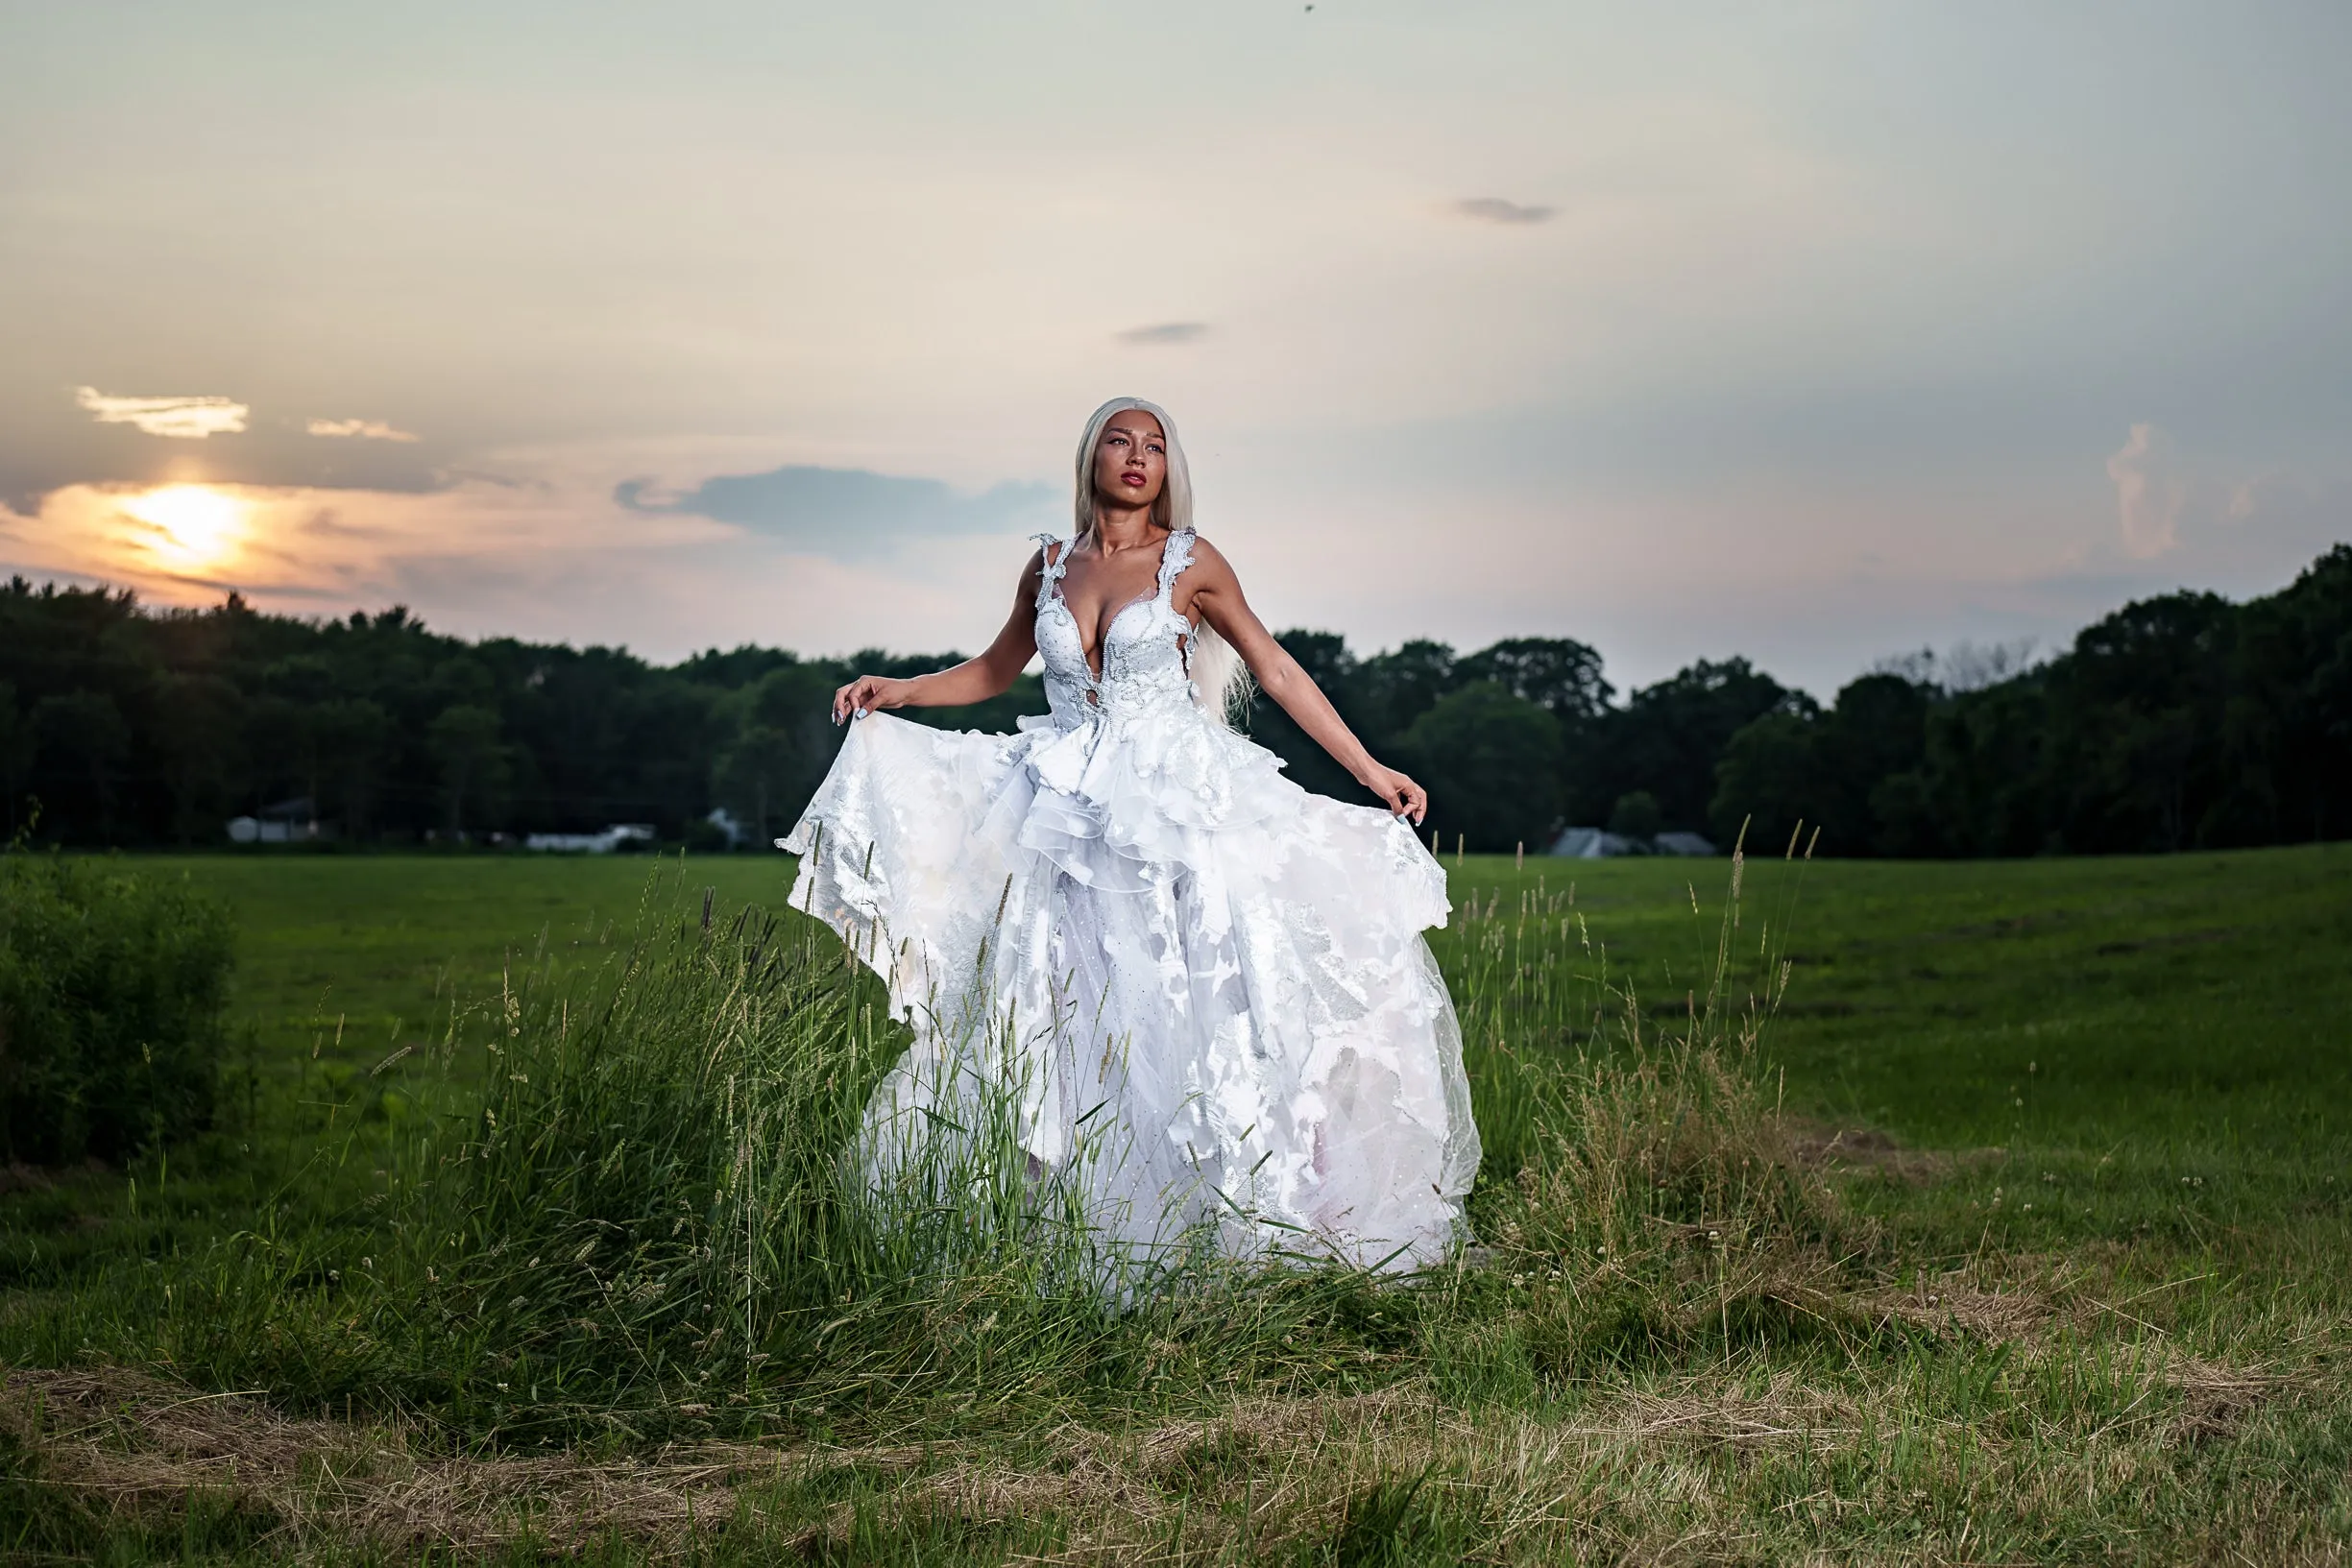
left=1037, top=529, right=1195, bottom=729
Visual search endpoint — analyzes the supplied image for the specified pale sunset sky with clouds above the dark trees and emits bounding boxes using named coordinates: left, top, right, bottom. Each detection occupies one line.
left=0, top=0, right=2352, bottom=696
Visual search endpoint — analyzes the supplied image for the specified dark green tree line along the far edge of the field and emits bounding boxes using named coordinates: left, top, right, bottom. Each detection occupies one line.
left=0, top=545, right=2352, bottom=856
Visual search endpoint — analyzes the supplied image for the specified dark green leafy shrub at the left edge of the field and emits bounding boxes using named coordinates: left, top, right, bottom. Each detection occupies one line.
left=0, top=851, right=235, bottom=1164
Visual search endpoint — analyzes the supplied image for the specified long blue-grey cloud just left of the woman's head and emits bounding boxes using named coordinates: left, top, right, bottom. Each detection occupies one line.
left=612, top=463, right=1060, bottom=560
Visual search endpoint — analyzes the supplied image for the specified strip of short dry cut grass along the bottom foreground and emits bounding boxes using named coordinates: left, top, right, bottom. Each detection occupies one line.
left=0, top=1316, right=2342, bottom=1563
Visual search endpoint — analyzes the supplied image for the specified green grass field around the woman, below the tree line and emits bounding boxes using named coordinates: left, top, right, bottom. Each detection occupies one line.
left=0, top=846, right=2352, bottom=1563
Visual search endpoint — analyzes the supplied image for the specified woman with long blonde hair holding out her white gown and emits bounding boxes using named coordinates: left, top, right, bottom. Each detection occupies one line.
left=779, top=398, right=1479, bottom=1269
